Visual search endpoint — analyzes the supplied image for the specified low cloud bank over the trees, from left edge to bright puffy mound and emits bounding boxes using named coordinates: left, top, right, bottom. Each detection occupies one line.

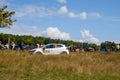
left=0, top=25, right=70, bottom=40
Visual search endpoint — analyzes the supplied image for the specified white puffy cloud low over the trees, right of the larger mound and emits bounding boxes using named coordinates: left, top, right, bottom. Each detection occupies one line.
left=81, top=30, right=100, bottom=44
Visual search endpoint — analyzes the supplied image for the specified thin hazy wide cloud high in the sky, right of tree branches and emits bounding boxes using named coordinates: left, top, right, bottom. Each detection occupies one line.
left=15, top=5, right=56, bottom=17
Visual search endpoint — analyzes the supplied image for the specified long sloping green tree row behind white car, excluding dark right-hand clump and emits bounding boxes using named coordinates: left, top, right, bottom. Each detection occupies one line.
left=0, top=33, right=99, bottom=50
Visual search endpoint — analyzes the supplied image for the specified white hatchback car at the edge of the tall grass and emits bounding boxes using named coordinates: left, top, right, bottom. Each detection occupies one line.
left=30, top=44, right=69, bottom=55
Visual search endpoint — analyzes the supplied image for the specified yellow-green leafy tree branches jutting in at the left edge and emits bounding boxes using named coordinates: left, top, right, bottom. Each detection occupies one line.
left=0, top=5, right=16, bottom=28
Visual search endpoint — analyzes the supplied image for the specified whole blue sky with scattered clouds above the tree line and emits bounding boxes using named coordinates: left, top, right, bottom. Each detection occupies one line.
left=0, top=0, right=120, bottom=44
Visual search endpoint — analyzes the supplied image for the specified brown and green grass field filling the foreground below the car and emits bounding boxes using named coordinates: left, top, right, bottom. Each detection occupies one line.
left=0, top=50, right=120, bottom=80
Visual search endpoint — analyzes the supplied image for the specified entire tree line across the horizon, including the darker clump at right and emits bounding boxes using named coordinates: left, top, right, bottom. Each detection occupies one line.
left=0, top=33, right=120, bottom=51
